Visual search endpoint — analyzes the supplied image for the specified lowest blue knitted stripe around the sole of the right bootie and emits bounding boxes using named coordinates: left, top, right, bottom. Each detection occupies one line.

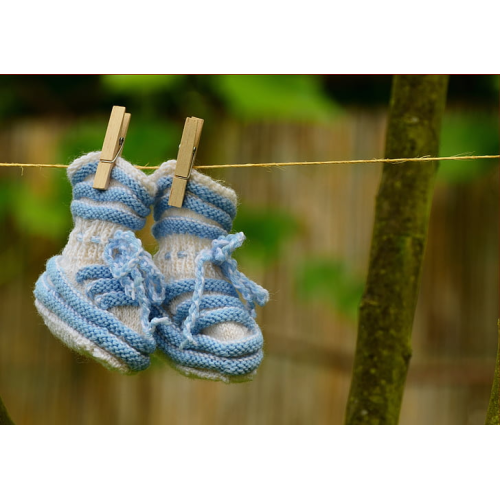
left=158, top=337, right=263, bottom=376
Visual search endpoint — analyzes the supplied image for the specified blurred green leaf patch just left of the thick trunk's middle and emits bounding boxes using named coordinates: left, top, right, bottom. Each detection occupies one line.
left=295, top=258, right=364, bottom=319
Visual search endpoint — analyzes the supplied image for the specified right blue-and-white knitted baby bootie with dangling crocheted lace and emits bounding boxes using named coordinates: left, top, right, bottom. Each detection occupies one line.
left=151, top=160, right=268, bottom=382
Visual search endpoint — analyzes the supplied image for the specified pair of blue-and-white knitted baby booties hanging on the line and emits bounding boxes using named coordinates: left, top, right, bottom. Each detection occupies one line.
left=35, top=152, right=268, bottom=382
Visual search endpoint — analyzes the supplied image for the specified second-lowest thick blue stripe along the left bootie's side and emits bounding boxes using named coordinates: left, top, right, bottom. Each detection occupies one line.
left=47, top=256, right=155, bottom=354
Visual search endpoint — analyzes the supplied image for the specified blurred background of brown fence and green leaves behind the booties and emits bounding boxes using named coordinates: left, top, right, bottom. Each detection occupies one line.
left=0, top=75, right=500, bottom=424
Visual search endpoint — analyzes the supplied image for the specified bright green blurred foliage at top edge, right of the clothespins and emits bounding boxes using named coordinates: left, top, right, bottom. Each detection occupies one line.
left=213, top=75, right=339, bottom=121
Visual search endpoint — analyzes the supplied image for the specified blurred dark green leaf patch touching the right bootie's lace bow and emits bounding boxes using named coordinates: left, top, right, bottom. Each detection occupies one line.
left=234, top=206, right=299, bottom=267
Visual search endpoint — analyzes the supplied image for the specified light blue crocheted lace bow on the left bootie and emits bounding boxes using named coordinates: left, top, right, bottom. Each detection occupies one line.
left=103, top=230, right=166, bottom=334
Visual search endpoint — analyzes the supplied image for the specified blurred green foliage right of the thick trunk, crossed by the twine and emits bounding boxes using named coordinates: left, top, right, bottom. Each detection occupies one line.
left=438, top=110, right=500, bottom=182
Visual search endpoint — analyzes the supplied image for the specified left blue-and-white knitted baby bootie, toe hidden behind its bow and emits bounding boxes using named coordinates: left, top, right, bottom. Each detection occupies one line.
left=35, top=152, right=165, bottom=373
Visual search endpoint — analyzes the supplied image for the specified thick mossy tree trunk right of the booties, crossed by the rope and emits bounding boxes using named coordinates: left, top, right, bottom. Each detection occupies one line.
left=346, top=75, right=448, bottom=424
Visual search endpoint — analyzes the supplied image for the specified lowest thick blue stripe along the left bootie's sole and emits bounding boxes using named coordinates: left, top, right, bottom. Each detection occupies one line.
left=35, top=273, right=150, bottom=371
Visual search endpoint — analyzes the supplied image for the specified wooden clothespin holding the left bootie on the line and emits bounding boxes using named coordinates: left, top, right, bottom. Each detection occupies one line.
left=93, top=106, right=130, bottom=189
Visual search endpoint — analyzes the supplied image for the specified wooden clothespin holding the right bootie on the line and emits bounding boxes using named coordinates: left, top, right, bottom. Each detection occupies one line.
left=168, top=117, right=203, bottom=208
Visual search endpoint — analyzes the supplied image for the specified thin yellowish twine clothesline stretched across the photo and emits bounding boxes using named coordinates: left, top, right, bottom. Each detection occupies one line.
left=0, top=155, right=500, bottom=170
